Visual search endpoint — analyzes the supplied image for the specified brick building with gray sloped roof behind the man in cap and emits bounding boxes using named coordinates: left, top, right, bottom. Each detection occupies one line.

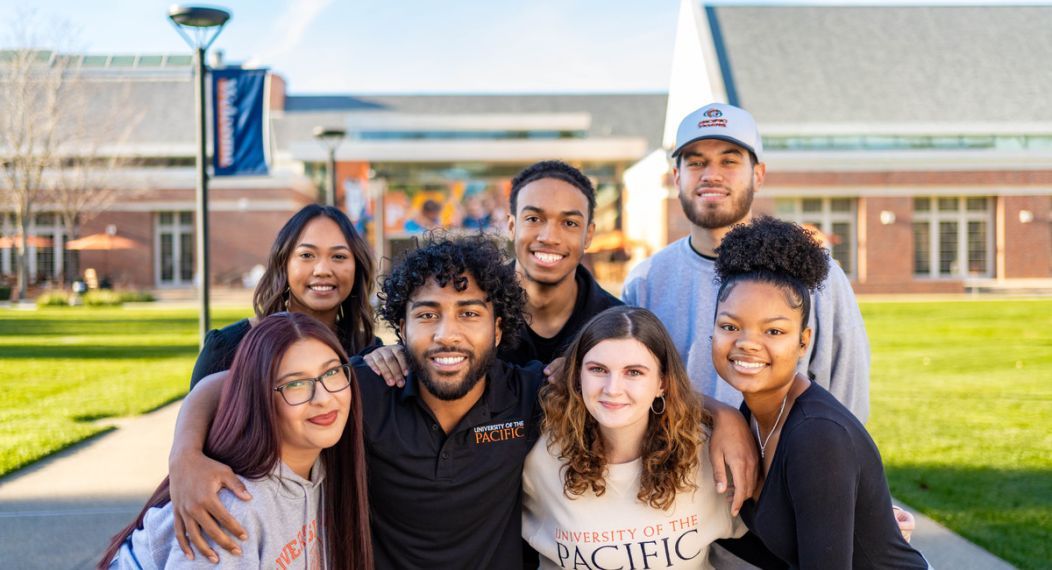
left=626, top=0, right=1052, bottom=293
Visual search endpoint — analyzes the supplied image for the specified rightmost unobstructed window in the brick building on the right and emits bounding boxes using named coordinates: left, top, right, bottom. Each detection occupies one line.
left=913, top=196, right=993, bottom=278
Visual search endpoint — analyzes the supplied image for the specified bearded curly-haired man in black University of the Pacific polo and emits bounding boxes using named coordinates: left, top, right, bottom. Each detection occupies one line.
left=170, top=237, right=544, bottom=568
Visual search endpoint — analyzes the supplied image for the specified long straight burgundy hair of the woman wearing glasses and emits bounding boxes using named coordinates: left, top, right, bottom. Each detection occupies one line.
left=99, top=312, right=372, bottom=570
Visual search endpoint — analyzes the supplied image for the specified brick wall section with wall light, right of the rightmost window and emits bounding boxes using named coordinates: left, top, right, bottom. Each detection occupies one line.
left=1004, top=196, right=1052, bottom=279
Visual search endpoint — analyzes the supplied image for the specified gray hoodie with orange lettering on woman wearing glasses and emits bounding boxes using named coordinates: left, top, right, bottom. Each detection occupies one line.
left=109, top=460, right=326, bottom=570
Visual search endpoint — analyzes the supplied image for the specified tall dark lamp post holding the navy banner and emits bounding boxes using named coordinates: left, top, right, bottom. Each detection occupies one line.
left=168, top=4, right=230, bottom=345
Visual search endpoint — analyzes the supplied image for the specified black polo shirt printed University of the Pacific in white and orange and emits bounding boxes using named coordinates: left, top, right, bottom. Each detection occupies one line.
left=352, top=358, right=544, bottom=569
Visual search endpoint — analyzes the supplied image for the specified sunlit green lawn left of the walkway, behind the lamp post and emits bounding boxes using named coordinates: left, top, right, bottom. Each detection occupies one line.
left=0, top=308, right=250, bottom=475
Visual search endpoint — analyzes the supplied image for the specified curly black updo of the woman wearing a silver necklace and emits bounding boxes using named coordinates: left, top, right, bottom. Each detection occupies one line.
left=716, top=216, right=829, bottom=327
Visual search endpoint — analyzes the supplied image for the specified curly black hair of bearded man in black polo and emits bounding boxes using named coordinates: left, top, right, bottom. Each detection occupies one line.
left=377, top=233, right=526, bottom=345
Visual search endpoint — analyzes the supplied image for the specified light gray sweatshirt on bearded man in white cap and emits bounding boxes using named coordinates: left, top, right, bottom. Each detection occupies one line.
left=622, top=238, right=869, bottom=422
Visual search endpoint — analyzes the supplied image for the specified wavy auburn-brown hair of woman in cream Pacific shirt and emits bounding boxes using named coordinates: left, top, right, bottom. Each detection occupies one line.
left=541, top=306, right=712, bottom=510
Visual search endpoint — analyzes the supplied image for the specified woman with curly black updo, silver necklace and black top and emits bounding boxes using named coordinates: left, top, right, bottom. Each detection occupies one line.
left=712, top=217, right=929, bottom=569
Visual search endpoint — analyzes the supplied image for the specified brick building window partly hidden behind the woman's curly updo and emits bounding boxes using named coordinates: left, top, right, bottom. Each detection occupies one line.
left=774, top=198, right=857, bottom=276
